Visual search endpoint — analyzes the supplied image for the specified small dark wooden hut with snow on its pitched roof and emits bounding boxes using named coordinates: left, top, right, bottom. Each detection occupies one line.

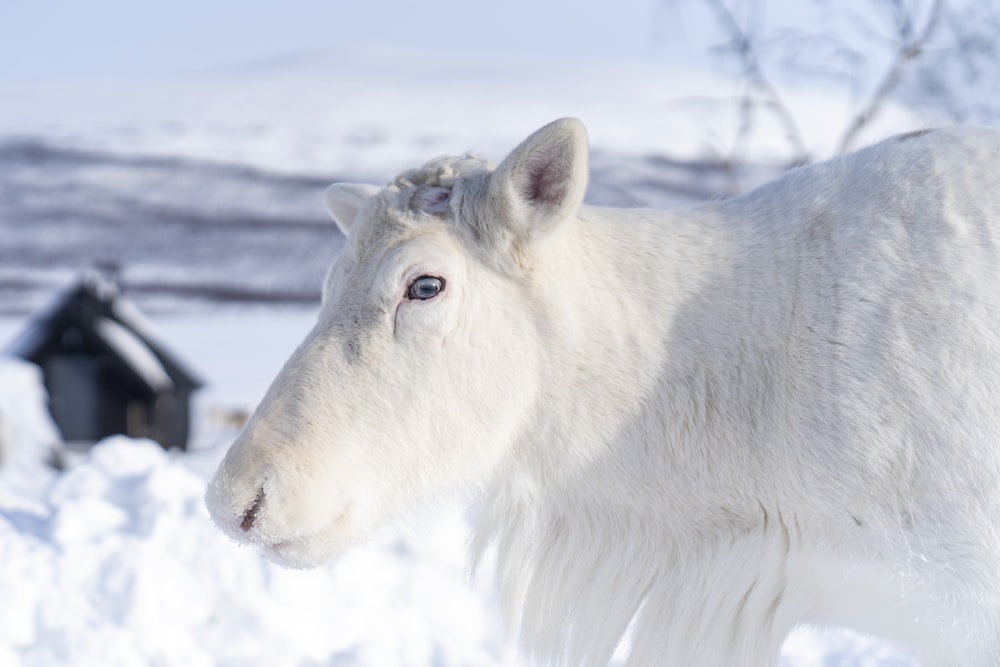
left=9, top=275, right=202, bottom=449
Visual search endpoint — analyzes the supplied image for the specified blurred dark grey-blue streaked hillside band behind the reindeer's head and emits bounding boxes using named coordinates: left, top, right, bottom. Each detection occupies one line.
left=0, top=137, right=778, bottom=315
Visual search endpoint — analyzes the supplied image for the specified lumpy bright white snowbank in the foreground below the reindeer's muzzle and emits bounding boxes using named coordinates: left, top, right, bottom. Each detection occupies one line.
left=0, top=438, right=514, bottom=667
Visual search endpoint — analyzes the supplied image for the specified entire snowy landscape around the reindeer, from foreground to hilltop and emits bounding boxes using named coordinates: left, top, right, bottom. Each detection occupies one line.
left=0, top=53, right=928, bottom=667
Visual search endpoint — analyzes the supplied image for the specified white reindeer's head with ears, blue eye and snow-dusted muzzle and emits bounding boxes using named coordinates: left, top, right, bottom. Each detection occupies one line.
left=207, top=119, right=587, bottom=567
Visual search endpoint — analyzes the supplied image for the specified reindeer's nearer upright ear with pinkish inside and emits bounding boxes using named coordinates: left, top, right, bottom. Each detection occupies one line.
left=489, top=118, right=587, bottom=237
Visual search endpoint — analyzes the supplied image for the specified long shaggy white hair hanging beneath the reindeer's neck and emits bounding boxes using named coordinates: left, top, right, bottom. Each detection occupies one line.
left=469, top=488, right=794, bottom=667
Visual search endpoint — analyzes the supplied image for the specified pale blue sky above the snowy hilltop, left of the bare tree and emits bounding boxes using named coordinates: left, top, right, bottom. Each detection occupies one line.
left=0, top=0, right=703, bottom=82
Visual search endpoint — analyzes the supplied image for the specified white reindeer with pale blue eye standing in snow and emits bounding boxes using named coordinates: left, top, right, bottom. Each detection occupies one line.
left=207, top=120, right=1000, bottom=667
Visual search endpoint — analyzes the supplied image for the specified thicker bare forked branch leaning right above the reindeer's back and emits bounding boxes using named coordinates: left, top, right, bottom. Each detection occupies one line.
left=837, top=0, right=943, bottom=153
